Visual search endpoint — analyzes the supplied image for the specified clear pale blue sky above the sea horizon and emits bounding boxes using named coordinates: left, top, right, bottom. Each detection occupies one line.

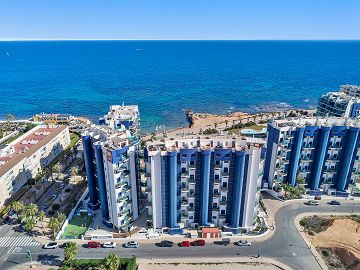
left=0, top=0, right=360, bottom=39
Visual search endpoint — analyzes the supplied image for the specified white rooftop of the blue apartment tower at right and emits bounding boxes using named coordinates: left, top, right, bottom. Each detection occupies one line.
left=272, top=117, right=360, bottom=127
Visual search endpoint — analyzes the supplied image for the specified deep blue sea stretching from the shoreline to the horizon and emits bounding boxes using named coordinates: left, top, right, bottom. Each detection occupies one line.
left=0, top=41, right=360, bottom=131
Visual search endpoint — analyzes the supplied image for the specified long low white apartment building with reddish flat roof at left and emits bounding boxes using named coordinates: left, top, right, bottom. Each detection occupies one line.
left=0, top=125, right=70, bottom=207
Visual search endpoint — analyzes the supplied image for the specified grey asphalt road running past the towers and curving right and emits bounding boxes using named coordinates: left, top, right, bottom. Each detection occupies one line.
left=0, top=201, right=360, bottom=270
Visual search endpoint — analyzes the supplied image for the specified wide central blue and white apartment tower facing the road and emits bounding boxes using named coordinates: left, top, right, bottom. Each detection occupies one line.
left=145, top=136, right=264, bottom=233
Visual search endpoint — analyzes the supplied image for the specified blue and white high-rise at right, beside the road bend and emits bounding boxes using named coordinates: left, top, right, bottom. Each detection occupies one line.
left=264, top=117, right=360, bottom=192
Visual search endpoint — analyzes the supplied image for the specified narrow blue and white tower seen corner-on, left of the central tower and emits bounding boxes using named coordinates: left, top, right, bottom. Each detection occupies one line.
left=82, top=105, right=139, bottom=231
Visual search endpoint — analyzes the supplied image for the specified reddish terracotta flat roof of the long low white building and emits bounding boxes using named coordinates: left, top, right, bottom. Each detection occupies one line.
left=0, top=126, right=67, bottom=176
